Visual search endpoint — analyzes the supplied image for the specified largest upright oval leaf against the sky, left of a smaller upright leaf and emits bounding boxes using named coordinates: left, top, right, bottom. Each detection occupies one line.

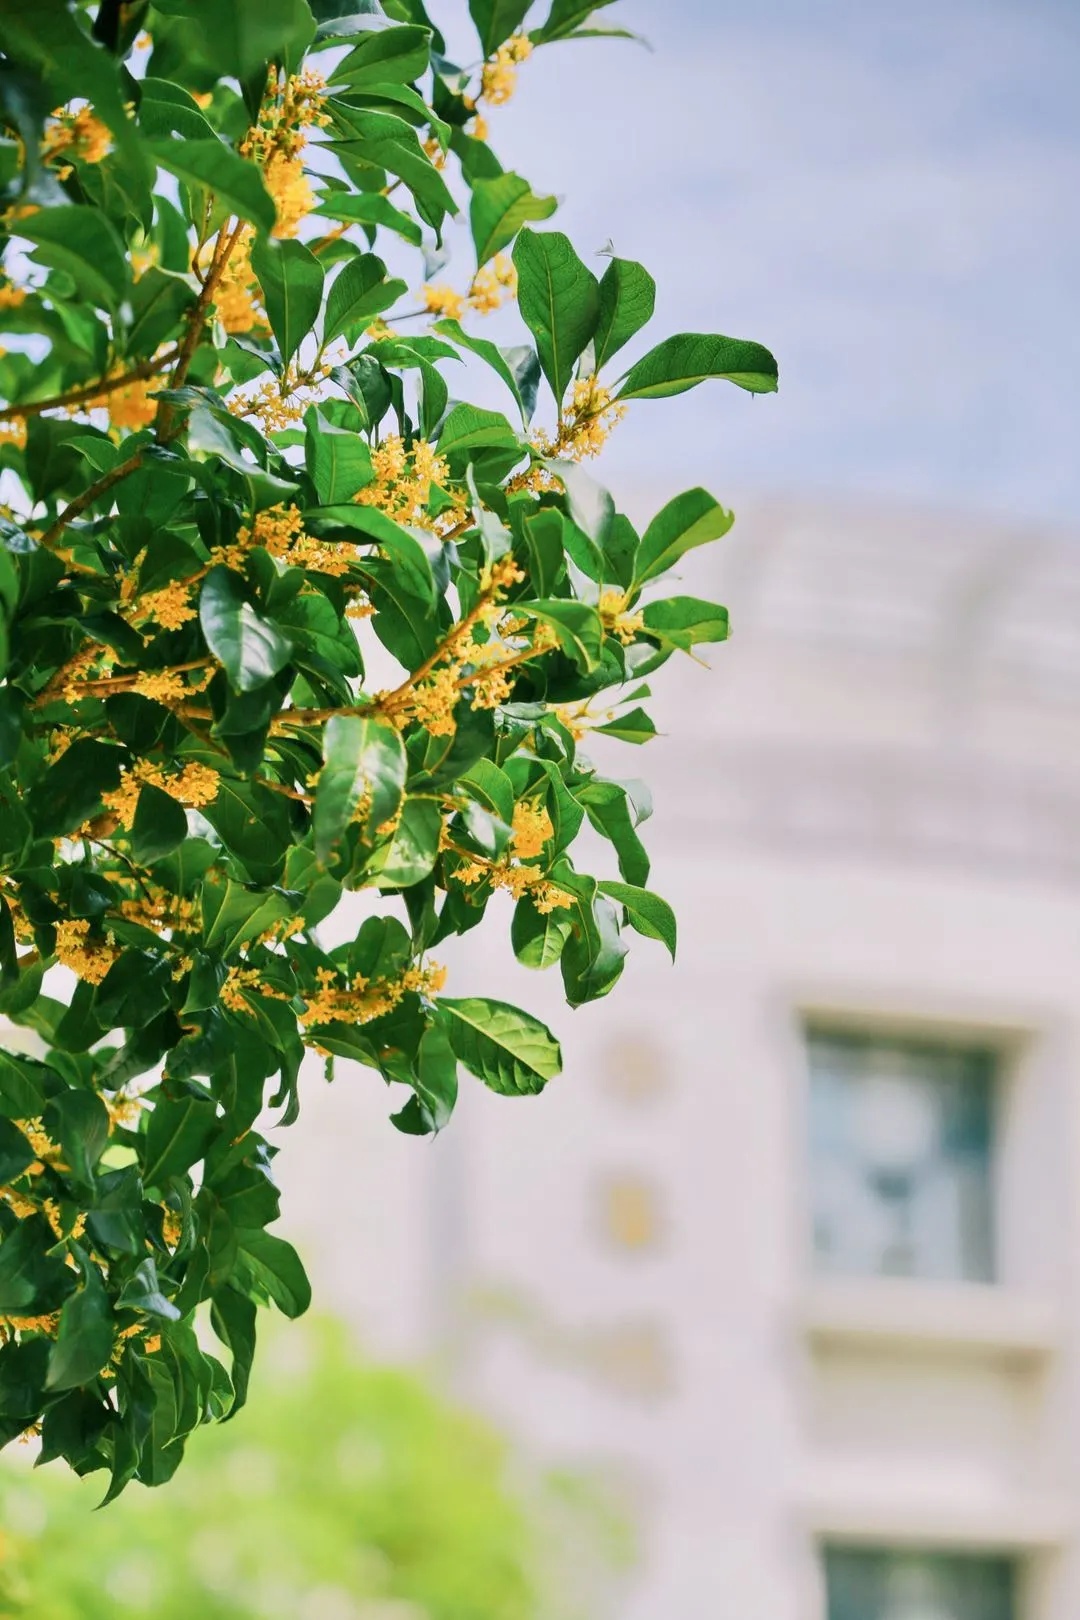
left=513, top=230, right=599, bottom=405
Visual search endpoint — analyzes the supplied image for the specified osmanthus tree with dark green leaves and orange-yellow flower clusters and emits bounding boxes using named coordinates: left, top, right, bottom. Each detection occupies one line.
left=0, top=0, right=777, bottom=1495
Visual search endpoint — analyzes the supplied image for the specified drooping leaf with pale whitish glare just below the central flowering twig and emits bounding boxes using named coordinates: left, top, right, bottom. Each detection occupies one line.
left=314, top=714, right=406, bottom=865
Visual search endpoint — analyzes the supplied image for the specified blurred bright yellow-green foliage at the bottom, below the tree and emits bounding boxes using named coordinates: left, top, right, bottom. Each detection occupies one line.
left=0, top=1322, right=621, bottom=1620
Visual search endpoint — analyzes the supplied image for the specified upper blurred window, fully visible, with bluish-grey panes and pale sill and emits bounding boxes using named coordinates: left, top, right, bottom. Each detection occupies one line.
left=808, top=1030, right=996, bottom=1281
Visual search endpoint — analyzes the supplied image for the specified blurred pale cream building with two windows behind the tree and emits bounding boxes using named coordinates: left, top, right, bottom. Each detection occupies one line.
left=282, top=504, right=1080, bottom=1620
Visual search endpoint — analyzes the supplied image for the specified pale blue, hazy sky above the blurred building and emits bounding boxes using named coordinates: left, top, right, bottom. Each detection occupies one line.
left=432, top=0, right=1080, bottom=523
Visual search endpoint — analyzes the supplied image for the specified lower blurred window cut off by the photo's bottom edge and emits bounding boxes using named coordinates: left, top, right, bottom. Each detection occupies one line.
left=826, top=1547, right=1017, bottom=1620
